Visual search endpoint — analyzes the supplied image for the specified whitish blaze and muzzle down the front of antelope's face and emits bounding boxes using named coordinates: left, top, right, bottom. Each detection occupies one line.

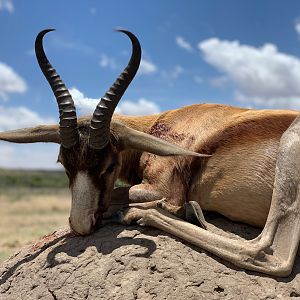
left=69, top=171, right=100, bottom=235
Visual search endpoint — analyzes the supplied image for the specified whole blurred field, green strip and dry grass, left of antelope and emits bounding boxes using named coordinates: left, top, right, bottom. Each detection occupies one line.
left=0, top=169, right=70, bottom=263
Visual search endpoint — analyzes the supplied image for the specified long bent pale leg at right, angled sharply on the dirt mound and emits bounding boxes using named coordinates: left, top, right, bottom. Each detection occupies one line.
left=119, top=117, right=300, bottom=276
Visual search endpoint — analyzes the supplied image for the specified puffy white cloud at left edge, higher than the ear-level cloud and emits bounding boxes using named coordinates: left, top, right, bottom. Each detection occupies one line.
left=0, top=62, right=27, bottom=100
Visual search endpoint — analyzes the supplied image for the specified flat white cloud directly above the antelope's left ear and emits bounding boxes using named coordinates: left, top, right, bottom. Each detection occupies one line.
left=0, top=106, right=56, bottom=131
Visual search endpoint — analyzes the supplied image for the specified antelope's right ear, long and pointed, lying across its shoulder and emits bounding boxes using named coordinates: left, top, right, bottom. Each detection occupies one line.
left=111, top=121, right=211, bottom=157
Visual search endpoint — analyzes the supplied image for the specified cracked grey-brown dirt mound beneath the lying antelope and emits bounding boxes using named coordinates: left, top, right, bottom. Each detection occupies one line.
left=0, top=219, right=300, bottom=300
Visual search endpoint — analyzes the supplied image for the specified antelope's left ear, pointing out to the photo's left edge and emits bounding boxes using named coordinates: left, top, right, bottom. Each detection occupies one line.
left=0, top=125, right=60, bottom=144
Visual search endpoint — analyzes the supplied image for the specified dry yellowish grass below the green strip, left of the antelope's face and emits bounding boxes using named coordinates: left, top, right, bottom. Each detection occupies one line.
left=0, top=188, right=70, bottom=263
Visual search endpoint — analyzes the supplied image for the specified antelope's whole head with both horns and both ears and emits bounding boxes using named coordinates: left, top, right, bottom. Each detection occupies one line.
left=0, top=29, right=207, bottom=235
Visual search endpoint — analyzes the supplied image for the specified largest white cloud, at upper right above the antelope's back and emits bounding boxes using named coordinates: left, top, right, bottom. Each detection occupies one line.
left=198, top=38, right=300, bottom=107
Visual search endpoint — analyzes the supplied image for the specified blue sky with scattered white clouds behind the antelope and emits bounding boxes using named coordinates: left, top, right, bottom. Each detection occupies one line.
left=0, top=0, right=300, bottom=168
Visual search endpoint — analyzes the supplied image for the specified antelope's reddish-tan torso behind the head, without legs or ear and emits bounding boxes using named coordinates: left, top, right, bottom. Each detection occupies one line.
left=114, top=104, right=298, bottom=227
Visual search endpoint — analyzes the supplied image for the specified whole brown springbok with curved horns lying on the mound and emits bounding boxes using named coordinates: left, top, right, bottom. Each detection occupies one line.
left=0, top=29, right=300, bottom=276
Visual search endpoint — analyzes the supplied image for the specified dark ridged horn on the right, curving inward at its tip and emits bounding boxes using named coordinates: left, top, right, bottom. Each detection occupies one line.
left=89, top=29, right=142, bottom=150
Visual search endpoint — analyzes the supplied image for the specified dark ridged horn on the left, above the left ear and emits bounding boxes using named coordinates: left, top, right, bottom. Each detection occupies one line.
left=35, top=29, right=79, bottom=148
